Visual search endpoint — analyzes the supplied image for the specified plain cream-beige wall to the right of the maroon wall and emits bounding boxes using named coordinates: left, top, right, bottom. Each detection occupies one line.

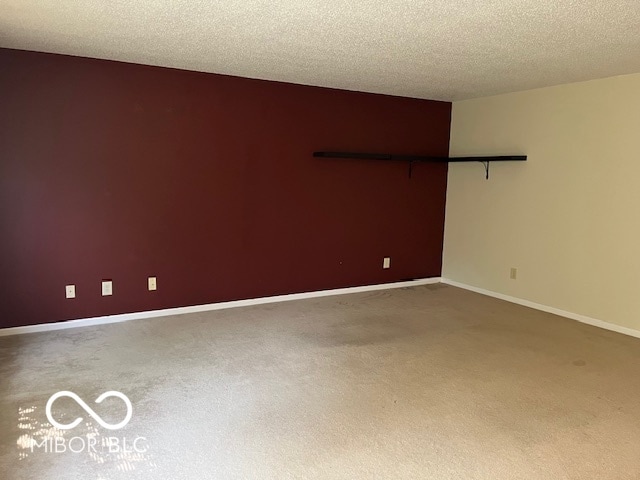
left=443, top=74, right=640, bottom=330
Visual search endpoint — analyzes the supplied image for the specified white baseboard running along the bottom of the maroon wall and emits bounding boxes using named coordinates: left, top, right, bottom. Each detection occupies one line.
left=0, top=277, right=440, bottom=337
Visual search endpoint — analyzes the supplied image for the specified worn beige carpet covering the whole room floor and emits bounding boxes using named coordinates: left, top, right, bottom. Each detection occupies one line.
left=0, top=285, right=640, bottom=480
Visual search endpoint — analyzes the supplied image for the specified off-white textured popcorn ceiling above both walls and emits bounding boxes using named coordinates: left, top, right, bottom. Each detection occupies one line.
left=0, top=0, right=640, bottom=100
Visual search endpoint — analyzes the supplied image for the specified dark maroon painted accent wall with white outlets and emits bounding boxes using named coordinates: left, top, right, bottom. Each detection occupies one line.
left=0, top=49, right=451, bottom=327
